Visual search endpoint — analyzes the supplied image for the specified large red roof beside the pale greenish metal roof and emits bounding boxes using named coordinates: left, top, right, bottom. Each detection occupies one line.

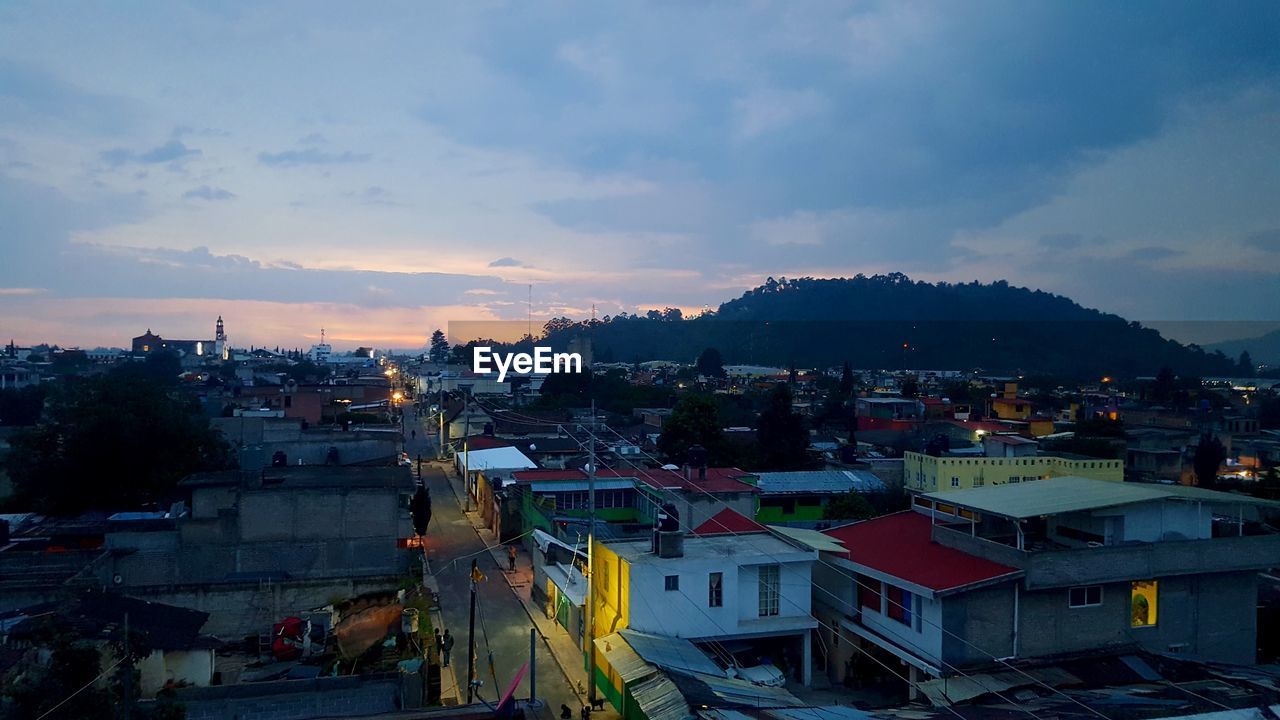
left=824, top=510, right=1019, bottom=592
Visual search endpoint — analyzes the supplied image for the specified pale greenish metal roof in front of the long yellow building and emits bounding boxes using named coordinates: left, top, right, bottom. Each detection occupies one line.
left=924, top=475, right=1280, bottom=519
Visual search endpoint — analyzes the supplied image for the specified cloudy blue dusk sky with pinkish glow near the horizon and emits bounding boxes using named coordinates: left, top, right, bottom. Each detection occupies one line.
left=0, top=0, right=1280, bottom=347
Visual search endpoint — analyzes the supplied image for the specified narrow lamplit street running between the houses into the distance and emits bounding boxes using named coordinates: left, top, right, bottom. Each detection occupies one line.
left=404, top=414, right=586, bottom=720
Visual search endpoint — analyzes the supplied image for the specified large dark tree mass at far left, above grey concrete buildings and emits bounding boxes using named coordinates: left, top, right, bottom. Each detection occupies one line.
left=5, top=365, right=227, bottom=515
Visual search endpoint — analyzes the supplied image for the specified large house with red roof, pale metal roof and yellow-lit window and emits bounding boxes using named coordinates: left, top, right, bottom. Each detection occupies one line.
left=814, top=477, right=1280, bottom=682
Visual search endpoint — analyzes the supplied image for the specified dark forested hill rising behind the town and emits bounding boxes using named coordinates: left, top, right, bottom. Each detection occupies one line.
left=527, top=273, right=1233, bottom=378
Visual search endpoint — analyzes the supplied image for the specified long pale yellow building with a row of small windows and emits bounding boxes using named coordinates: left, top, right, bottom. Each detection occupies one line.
left=902, top=452, right=1124, bottom=492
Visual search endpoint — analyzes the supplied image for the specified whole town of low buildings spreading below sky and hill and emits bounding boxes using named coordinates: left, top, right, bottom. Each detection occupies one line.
left=0, top=316, right=1280, bottom=720
